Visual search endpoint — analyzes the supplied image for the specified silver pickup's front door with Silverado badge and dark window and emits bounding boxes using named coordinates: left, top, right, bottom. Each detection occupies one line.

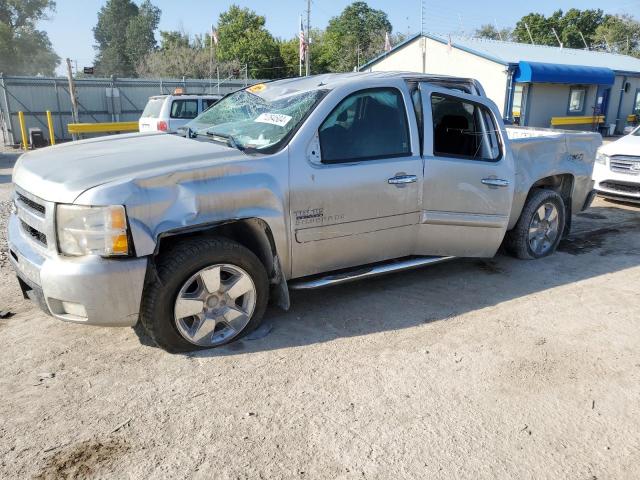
left=290, top=87, right=423, bottom=277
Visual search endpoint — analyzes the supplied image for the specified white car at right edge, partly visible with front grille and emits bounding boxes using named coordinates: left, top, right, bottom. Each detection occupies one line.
left=593, top=127, right=640, bottom=202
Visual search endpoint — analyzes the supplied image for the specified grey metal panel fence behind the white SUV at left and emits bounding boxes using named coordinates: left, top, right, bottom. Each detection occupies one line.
left=0, top=74, right=261, bottom=145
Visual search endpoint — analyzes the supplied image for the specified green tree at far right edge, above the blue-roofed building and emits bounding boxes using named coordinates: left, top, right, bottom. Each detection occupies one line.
left=594, top=15, right=640, bottom=57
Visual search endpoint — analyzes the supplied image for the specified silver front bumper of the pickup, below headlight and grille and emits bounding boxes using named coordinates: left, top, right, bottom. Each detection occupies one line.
left=8, top=214, right=147, bottom=327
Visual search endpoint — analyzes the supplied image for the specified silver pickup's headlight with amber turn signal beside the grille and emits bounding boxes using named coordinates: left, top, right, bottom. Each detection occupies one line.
left=56, top=205, right=130, bottom=257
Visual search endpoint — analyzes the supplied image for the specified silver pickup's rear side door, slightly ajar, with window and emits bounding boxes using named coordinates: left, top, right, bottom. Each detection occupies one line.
left=416, top=83, right=515, bottom=257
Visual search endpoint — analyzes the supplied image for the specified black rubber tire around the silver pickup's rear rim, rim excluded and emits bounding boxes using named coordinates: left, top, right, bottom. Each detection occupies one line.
left=504, top=189, right=566, bottom=260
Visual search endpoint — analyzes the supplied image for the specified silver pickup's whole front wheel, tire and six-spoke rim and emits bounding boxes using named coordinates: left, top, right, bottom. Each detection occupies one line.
left=140, top=238, right=269, bottom=352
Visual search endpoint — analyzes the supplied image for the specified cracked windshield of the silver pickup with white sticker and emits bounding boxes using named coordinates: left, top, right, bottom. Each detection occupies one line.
left=188, top=83, right=324, bottom=151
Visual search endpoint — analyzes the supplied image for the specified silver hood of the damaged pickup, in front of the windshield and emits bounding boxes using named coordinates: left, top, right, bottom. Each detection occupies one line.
left=13, top=133, right=246, bottom=203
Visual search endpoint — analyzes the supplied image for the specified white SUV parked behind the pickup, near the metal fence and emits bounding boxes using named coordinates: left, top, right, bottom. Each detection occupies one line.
left=138, top=94, right=222, bottom=133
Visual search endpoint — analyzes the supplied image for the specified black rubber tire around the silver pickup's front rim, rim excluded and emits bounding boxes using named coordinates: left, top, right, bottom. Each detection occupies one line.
left=140, top=238, right=269, bottom=353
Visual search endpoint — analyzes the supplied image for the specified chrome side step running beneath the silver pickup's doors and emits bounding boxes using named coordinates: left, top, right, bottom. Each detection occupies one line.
left=289, top=257, right=455, bottom=290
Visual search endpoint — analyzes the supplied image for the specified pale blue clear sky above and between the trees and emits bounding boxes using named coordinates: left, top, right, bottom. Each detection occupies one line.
left=39, top=0, right=640, bottom=74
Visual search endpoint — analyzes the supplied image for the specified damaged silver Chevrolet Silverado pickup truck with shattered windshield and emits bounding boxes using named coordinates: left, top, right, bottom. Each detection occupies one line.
left=8, top=73, right=601, bottom=351
